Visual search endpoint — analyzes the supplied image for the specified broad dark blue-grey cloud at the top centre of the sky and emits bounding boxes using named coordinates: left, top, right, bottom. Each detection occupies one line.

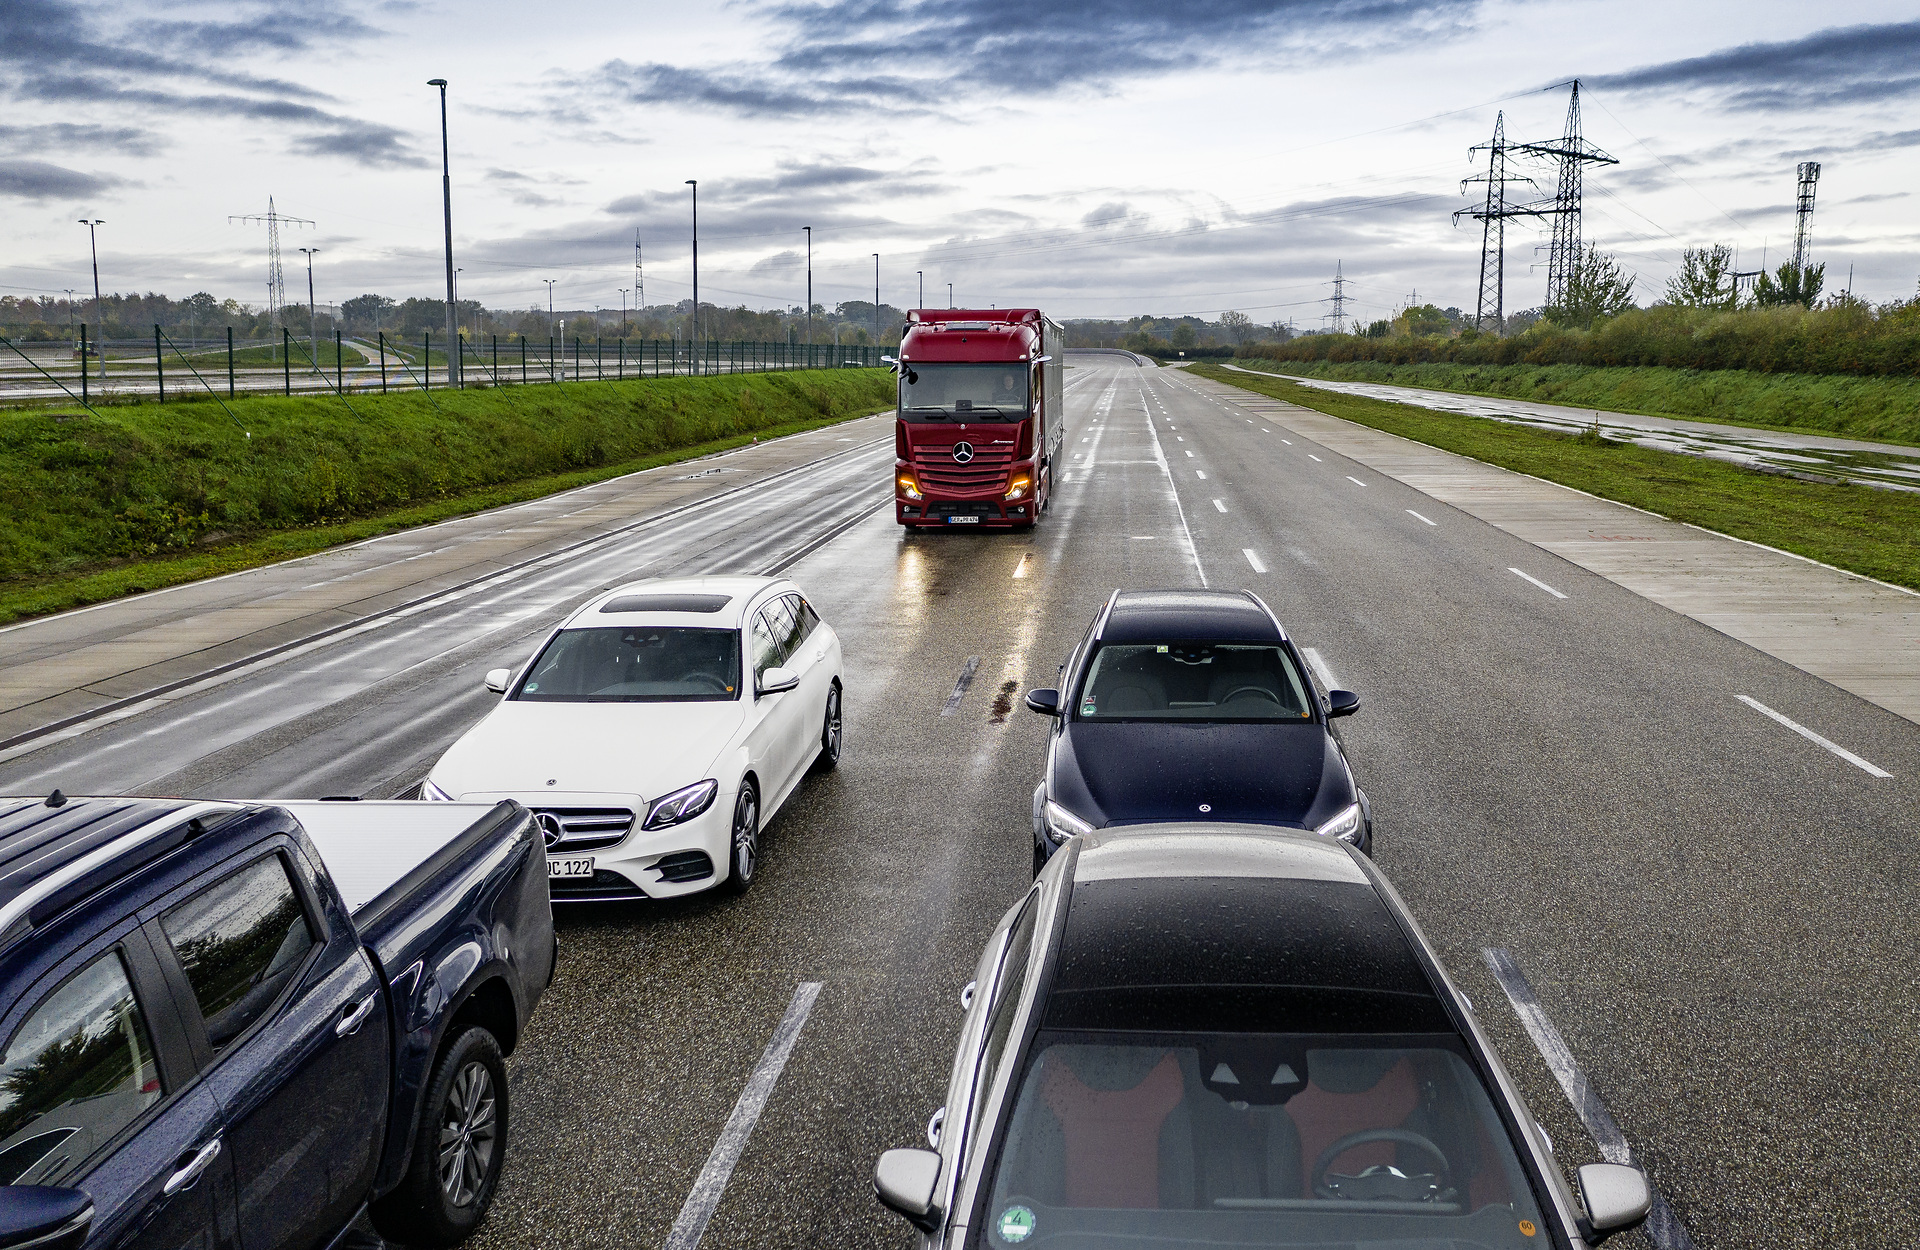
left=576, top=0, right=1478, bottom=117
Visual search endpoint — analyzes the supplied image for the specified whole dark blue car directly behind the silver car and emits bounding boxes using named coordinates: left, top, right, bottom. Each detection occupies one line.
left=1027, top=589, right=1373, bottom=872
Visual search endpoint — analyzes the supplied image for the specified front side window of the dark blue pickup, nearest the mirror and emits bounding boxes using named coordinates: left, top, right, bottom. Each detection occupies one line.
left=0, top=950, right=161, bottom=1185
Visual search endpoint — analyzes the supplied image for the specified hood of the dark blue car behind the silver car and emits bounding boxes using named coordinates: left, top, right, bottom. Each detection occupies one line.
left=1046, top=720, right=1354, bottom=828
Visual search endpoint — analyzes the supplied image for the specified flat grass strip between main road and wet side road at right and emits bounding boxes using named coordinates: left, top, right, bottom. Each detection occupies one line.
left=1188, top=365, right=1920, bottom=589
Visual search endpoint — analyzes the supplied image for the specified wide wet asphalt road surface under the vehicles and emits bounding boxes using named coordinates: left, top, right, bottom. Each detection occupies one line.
left=0, top=355, right=1920, bottom=1248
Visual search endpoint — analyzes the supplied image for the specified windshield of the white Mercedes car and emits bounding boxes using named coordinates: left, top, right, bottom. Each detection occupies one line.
left=513, top=626, right=739, bottom=703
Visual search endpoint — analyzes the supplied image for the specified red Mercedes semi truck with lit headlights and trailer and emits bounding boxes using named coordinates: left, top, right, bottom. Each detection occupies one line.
left=893, top=307, right=1066, bottom=530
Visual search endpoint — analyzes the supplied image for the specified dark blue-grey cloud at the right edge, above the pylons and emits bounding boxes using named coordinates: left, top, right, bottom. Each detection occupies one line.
left=1584, top=21, right=1920, bottom=111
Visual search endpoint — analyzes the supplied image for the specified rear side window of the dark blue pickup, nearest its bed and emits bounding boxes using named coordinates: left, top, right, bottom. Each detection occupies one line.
left=159, top=854, right=313, bottom=1054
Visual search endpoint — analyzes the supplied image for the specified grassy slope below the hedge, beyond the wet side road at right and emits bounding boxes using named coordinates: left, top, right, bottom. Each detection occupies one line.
left=1235, top=359, right=1920, bottom=445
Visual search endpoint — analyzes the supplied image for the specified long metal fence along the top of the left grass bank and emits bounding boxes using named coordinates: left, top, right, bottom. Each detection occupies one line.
left=0, top=325, right=883, bottom=403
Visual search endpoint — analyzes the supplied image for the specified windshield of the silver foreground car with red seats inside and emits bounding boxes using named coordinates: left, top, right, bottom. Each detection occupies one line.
left=975, top=1033, right=1548, bottom=1250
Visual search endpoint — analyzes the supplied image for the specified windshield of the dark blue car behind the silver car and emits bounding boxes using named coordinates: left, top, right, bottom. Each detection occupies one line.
left=1073, top=643, right=1313, bottom=720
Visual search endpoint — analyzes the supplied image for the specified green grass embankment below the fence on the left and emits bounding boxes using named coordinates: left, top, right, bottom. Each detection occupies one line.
left=0, top=369, right=893, bottom=620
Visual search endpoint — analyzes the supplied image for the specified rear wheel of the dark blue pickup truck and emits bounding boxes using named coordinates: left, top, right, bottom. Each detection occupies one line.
left=372, top=1027, right=507, bottom=1246
